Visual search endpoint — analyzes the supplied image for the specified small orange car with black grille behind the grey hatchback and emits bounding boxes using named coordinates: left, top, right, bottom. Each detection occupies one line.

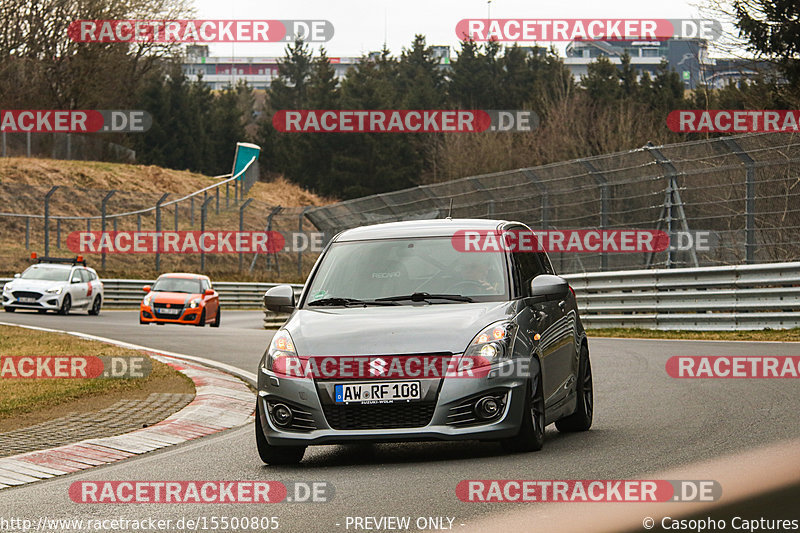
left=139, top=273, right=220, bottom=328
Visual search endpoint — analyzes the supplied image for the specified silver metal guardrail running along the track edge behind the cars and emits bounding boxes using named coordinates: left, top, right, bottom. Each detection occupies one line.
left=0, top=262, right=800, bottom=331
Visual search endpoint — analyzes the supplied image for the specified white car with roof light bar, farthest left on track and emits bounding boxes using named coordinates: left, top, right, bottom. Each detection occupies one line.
left=3, top=257, right=103, bottom=315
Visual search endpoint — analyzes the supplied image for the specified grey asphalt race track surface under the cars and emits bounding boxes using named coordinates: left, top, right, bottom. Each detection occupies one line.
left=0, top=311, right=800, bottom=532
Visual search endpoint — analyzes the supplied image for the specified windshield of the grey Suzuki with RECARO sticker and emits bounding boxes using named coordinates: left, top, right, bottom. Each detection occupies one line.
left=306, top=237, right=508, bottom=306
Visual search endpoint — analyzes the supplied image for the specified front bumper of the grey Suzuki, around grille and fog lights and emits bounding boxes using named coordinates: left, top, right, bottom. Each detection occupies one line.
left=258, top=362, right=526, bottom=446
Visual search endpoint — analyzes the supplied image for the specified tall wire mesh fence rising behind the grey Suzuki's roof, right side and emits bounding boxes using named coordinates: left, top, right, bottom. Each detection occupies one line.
left=307, top=133, right=800, bottom=273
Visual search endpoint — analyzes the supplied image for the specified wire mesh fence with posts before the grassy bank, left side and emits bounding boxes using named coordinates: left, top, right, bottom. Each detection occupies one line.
left=0, top=155, right=314, bottom=280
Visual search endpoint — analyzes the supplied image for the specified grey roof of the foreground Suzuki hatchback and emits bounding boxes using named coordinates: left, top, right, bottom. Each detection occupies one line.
left=335, top=218, right=519, bottom=242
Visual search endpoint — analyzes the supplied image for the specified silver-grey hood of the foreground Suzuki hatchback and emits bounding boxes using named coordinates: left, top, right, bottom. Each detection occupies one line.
left=284, top=302, right=515, bottom=357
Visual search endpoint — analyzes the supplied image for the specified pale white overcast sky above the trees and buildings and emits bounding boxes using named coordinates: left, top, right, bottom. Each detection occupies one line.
left=194, top=0, right=736, bottom=57
